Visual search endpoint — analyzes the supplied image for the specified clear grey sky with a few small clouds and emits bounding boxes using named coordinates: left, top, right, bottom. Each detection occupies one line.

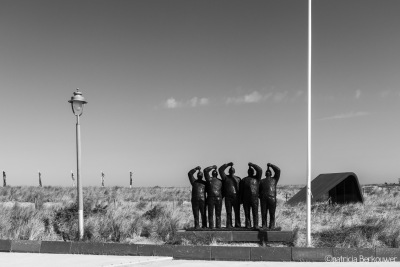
left=0, top=0, right=400, bottom=187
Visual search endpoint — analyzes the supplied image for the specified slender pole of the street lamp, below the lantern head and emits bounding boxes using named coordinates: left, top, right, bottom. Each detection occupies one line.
left=76, top=115, right=83, bottom=239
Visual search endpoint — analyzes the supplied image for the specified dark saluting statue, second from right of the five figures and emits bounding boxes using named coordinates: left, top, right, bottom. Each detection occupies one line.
left=240, top=162, right=262, bottom=229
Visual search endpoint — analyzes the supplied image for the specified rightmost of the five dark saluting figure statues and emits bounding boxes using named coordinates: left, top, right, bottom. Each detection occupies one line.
left=260, top=163, right=281, bottom=229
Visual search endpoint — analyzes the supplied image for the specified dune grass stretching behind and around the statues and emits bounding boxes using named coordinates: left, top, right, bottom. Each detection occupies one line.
left=0, top=186, right=400, bottom=248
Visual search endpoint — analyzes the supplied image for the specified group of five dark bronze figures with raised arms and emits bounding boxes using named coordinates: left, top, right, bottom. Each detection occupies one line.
left=188, top=162, right=281, bottom=229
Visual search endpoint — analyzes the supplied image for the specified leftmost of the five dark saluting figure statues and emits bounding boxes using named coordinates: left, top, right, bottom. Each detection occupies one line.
left=188, top=166, right=207, bottom=229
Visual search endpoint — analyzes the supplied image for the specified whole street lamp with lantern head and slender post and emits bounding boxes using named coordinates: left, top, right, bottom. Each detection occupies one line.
left=68, top=88, right=87, bottom=239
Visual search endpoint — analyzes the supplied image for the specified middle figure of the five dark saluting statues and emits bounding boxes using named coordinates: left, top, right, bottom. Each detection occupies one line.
left=218, top=162, right=240, bottom=228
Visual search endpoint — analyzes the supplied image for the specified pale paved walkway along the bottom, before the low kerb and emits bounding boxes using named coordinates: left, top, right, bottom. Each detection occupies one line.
left=0, top=252, right=399, bottom=267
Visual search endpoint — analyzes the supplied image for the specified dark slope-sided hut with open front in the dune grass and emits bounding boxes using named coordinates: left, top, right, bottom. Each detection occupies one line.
left=287, top=172, right=364, bottom=205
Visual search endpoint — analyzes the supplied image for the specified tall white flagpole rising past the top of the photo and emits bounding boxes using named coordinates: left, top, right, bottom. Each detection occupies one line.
left=307, top=0, right=312, bottom=247
